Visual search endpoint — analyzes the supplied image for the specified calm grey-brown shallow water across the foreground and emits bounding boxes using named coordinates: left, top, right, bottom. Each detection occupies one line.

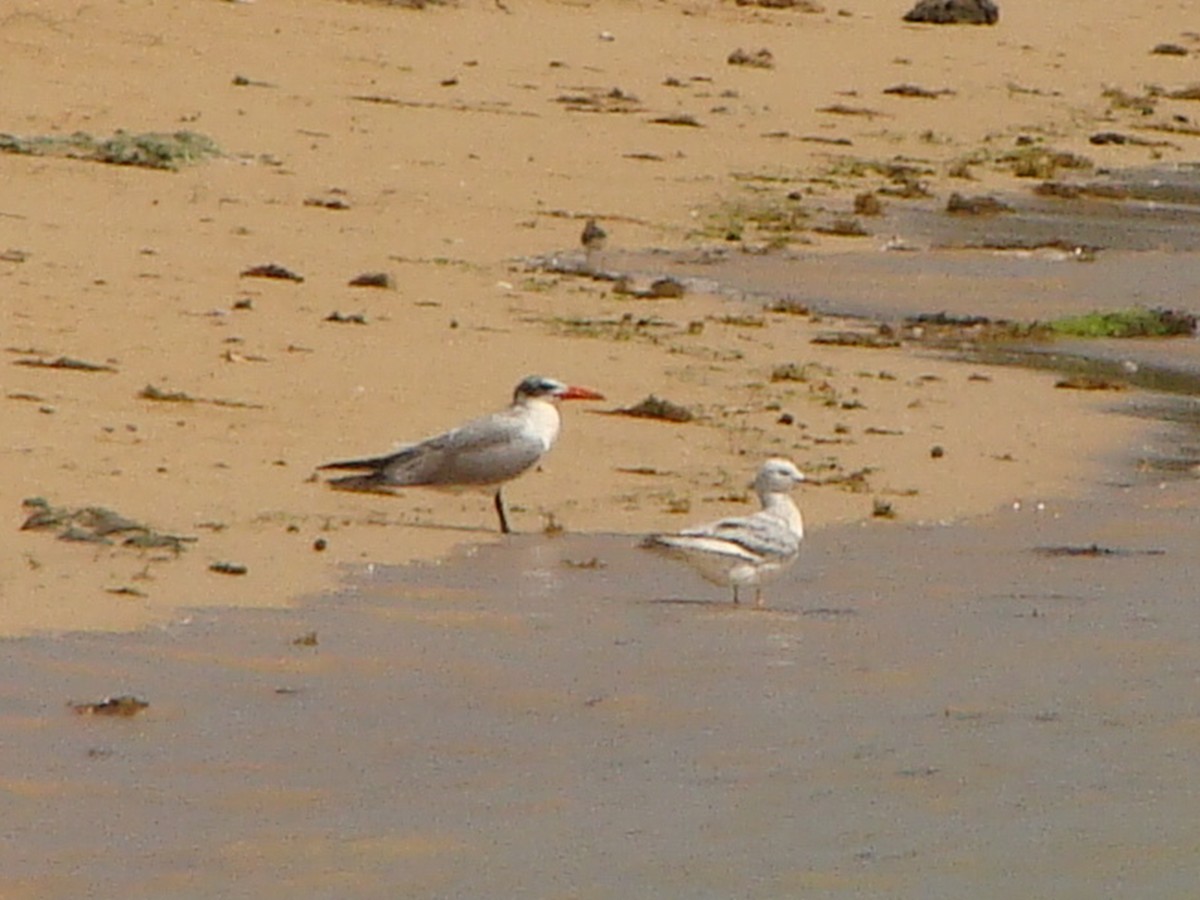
left=0, top=451, right=1200, bottom=899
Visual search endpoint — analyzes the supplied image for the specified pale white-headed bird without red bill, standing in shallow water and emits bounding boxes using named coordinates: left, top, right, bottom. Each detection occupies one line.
left=642, top=460, right=804, bottom=606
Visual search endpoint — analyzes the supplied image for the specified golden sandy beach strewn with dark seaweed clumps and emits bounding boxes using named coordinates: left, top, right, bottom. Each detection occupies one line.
left=0, top=0, right=1196, bottom=634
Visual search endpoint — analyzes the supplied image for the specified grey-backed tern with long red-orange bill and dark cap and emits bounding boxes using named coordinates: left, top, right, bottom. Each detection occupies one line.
left=318, top=376, right=604, bottom=534
